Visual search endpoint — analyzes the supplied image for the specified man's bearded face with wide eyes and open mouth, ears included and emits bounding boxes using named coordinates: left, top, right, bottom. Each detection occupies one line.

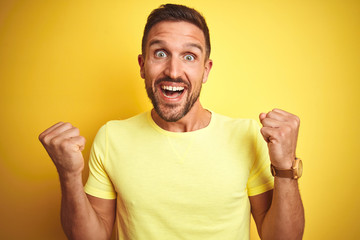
left=138, top=21, right=212, bottom=122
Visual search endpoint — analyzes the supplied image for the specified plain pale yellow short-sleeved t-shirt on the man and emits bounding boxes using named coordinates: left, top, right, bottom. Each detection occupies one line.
left=85, top=112, right=273, bottom=240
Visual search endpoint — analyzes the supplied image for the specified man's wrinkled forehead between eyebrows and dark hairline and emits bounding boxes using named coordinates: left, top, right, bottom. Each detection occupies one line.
left=146, top=21, right=205, bottom=49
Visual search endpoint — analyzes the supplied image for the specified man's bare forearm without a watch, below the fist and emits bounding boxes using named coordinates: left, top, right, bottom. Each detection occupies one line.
left=60, top=174, right=112, bottom=240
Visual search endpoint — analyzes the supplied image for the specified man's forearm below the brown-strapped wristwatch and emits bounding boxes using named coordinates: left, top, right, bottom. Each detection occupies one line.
left=261, top=177, right=305, bottom=240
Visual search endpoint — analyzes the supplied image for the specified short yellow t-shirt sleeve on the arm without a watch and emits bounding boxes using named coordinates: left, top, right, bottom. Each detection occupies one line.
left=84, top=125, right=116, bottom=199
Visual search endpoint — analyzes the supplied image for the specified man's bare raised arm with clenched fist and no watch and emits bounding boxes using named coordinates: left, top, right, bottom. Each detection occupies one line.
left=39, top=122, right=116, bottom=239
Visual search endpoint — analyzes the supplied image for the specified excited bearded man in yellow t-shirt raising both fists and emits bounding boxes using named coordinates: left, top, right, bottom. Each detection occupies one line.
left=39, top=4, right=304, bottom=240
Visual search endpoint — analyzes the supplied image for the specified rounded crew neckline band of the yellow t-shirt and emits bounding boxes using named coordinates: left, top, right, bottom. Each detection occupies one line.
left=146, top=109, right=216, bottom=136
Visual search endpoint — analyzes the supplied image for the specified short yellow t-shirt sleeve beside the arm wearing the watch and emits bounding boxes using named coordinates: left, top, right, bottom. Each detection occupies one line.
left=247, top=120, right=274, bottom=196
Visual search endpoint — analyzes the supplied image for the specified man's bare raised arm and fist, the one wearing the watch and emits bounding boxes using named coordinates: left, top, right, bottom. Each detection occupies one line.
left=250, top=109, right=305, bottom=240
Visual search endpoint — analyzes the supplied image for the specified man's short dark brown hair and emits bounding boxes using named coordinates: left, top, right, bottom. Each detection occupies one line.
left=141, top=4, right=211, bottom=58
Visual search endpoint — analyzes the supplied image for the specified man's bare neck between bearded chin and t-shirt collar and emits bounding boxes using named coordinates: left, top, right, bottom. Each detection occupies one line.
left=151, top=101, right=211, bottom=132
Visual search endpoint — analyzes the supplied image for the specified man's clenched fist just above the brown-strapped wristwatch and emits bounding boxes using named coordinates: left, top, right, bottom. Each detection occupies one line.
left=259, top=109, right=300, bottom=169
